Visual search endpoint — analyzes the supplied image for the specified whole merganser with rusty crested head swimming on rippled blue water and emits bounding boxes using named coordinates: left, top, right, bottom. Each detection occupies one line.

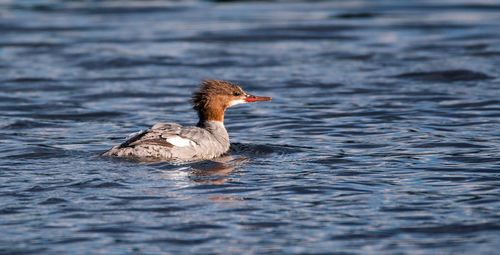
left=102, top=79, right=271, bottom=161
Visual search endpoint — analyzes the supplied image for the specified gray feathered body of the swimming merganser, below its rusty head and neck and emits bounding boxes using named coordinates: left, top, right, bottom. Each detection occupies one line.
left=103, top=121, right=229, bottom=161
